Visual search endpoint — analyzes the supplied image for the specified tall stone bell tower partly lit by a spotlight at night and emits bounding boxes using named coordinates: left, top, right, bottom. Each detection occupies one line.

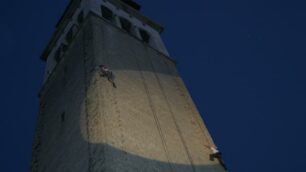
left=31, top=0, right=224, bottom=172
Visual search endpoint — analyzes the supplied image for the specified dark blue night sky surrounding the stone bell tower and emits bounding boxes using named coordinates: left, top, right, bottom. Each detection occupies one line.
left=0, top=0, right=306, bottom=172
